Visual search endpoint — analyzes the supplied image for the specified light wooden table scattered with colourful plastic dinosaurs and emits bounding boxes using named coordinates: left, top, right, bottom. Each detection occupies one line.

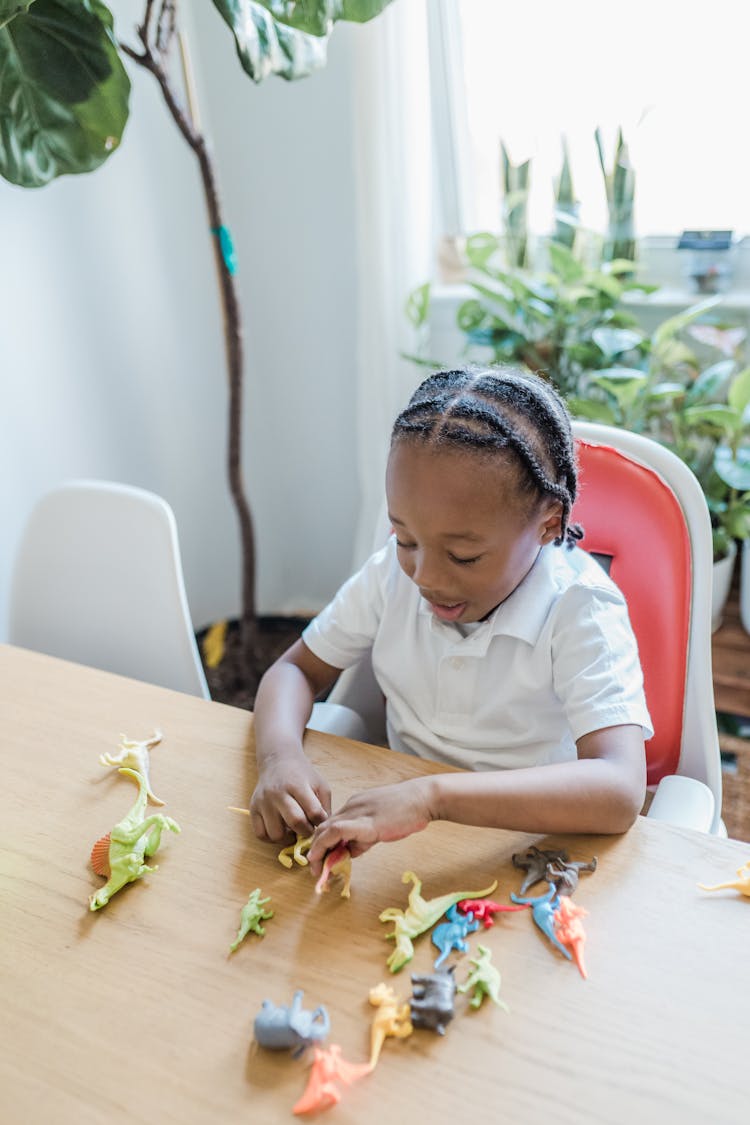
left=0, top=646, right=750, bottom=1125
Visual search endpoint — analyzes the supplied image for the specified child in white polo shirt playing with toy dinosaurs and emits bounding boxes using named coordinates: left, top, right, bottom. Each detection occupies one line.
left=251, top=368, right=652, bottom=874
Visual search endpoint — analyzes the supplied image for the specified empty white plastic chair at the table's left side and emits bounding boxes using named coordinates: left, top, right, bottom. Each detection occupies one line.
left=9, top=480, right=210, bottom=699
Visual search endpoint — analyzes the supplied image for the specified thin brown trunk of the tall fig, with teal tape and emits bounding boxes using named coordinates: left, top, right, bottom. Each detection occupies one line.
left=120, top=0, right=257, bottom=664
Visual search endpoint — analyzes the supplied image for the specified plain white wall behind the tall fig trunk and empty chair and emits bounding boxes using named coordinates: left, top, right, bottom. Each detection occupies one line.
left=0, top=0, right=367, bottom=640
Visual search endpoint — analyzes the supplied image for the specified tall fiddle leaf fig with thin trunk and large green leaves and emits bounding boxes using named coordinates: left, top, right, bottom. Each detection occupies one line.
left=0, top=0, right=391, bottom=662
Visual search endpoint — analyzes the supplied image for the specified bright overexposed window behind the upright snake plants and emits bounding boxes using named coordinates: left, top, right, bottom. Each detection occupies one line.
left=430, top=0, right=750, bottom=237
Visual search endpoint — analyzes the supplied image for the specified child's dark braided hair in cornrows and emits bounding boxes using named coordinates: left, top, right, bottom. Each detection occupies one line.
left=391, top=366, right=584, bottom=548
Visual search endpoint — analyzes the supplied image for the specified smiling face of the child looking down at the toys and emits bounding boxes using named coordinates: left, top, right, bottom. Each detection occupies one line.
left=386, top=442, right=560, bottom=623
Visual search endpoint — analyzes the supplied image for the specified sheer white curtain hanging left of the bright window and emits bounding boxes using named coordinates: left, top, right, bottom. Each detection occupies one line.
left=353, top=0, right=434, bottom=567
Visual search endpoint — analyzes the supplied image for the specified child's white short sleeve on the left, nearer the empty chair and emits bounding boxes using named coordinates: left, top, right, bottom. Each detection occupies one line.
left=302, top=543, right=394, bottom=668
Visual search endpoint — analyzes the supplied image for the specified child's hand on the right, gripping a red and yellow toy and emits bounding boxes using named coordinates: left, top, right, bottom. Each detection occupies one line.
left=307, top=777, right=434, bottom=876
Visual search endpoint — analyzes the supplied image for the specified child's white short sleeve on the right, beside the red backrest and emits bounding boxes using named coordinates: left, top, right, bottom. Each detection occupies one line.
left=552, top=586, right=653, bottom=741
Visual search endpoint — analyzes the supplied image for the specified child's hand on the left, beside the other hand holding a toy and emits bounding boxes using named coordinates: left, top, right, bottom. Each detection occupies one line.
left=250, top=752, right=331, bottom=843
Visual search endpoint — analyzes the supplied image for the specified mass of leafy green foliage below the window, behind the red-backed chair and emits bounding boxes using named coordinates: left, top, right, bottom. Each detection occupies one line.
left=407, top=233, right=750, bottom=627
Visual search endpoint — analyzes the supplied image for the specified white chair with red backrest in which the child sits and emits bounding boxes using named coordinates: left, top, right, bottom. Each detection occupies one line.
left=310, top=422, right=725, bottom=834
